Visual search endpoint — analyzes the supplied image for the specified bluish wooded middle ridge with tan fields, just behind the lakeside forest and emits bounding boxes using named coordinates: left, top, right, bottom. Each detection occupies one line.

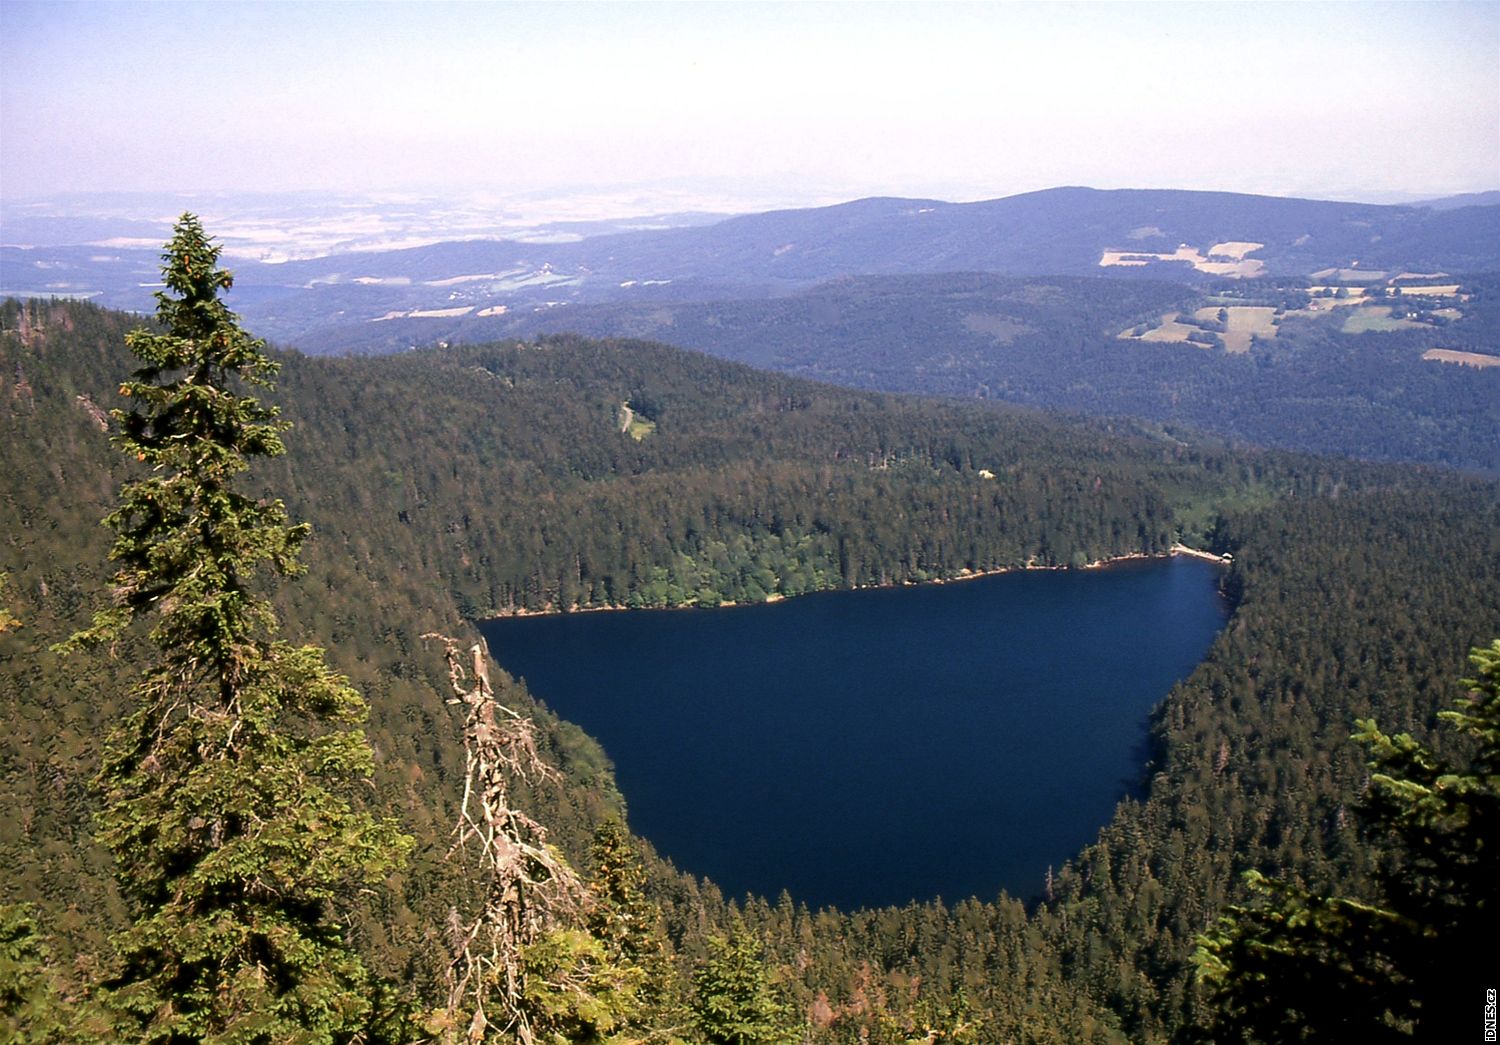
left=328, top=270, right=1500, bottom=471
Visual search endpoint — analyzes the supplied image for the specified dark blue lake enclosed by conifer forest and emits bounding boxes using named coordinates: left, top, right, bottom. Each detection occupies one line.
left=483, top=558, right=1227, bottom=909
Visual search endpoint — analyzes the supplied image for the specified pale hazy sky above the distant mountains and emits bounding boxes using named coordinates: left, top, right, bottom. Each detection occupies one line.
left=0, top=0, right=1500, bottom=199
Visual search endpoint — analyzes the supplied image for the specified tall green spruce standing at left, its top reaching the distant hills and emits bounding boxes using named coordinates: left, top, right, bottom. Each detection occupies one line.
left=72, top=214, right=410, bottom=1042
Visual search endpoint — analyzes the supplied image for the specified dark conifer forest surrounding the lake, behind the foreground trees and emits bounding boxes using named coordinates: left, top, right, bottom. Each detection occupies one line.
left=0, top=301, right=1500, bottom=1042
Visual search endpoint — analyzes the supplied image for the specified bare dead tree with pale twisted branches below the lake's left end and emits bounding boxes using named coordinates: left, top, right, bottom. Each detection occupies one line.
left=423, top=633, right=584, bottom=1045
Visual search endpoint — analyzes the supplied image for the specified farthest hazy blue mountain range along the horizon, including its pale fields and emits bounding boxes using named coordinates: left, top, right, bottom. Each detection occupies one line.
left=0, top=186, right=1500, bottom=343
